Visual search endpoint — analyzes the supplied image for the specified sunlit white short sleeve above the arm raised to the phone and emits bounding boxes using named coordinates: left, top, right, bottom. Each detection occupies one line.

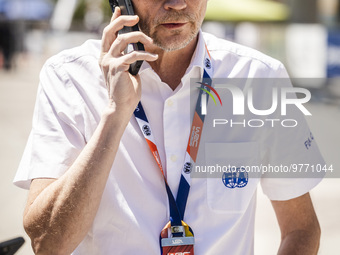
left=14, top=58, right=86, bottom=189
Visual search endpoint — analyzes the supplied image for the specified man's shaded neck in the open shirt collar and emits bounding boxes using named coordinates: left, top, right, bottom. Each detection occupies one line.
left=146, top=36, right=198, bottom=90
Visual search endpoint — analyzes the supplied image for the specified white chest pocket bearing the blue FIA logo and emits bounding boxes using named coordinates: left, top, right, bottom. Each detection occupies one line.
left=205, top=142, right=260, bottom=213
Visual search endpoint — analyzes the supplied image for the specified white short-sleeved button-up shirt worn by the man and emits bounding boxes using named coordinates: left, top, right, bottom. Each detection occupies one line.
left=14, top=32, right=323, bottom=255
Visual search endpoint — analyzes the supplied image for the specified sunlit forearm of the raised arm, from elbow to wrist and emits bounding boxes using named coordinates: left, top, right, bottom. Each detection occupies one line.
left=24, top=107, right=131, bottom=255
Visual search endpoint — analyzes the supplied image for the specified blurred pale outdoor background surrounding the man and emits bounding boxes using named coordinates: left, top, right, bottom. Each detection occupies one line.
left=0, top=0, right=340, bottom=255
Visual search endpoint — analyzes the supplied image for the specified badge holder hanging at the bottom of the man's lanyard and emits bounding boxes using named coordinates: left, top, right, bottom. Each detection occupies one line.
left=161, top=226, right=195, bottom=255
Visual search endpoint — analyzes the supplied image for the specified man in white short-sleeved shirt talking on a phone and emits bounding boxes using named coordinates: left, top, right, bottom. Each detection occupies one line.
left=15, top=0, right=322, bottom=255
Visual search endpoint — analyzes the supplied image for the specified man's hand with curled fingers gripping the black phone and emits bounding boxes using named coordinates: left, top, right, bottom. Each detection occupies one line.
left=99, top=7, right=158, bottom=110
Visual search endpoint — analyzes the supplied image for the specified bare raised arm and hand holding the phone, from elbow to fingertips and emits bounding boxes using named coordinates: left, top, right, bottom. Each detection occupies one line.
left=24, top=9, right=157, bottom=255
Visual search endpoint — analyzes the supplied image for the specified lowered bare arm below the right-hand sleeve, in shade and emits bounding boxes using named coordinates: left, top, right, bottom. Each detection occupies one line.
left=271, top=193, right=321, bottom=255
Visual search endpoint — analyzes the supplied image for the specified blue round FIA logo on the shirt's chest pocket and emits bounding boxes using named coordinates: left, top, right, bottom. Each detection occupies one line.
left=222, top=167, right=248, bottom=189
